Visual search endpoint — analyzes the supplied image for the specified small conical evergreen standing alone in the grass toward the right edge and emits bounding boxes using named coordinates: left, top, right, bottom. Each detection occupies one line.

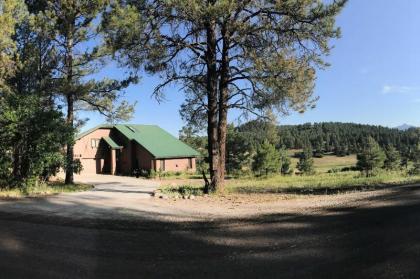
left=357, top=137, right=385, bottom=176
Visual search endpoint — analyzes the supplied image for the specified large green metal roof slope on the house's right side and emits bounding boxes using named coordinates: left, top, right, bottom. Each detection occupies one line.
left=115, top=124, right=199, bottom=159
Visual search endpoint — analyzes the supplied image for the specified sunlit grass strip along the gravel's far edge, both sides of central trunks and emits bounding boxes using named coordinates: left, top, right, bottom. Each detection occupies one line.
left=160, top=171, right=420, bottom=196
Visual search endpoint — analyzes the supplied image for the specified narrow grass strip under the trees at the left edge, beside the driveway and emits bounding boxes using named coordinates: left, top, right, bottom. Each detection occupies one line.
left=0, top=182, right=93, bottom=198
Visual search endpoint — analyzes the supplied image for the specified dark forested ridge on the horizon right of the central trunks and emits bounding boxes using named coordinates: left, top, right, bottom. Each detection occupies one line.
left=235, top=120, right=420, bottom=156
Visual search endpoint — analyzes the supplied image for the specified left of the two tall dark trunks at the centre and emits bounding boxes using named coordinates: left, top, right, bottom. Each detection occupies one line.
left=205, top=14, right=219, bottom=192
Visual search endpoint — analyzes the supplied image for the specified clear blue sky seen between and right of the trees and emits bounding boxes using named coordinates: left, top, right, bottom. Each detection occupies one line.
left=80, top=0, right=420, bottom=136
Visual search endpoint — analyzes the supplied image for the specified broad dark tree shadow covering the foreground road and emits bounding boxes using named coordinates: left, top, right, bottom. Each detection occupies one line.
left=0, top=187, right=420, bottom=278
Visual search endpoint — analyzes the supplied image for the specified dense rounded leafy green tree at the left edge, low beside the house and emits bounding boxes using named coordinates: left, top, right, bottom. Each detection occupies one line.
left=0, top=94, right=73, bottom=185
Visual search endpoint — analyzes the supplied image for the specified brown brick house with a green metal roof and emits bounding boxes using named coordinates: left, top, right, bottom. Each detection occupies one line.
left=74, top=124, right=199, bottom=175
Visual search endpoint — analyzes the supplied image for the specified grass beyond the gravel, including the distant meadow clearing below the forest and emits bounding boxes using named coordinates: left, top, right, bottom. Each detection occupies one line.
left=158, top=155, right=420, bottom=197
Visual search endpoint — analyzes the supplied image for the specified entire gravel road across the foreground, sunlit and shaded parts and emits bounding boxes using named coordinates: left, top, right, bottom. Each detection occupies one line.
left=0, top=179, right=420, bottom=278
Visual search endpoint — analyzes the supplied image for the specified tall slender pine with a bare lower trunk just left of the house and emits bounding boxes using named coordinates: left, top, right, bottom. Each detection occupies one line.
left=38, top=0, right=136, bottom=184
